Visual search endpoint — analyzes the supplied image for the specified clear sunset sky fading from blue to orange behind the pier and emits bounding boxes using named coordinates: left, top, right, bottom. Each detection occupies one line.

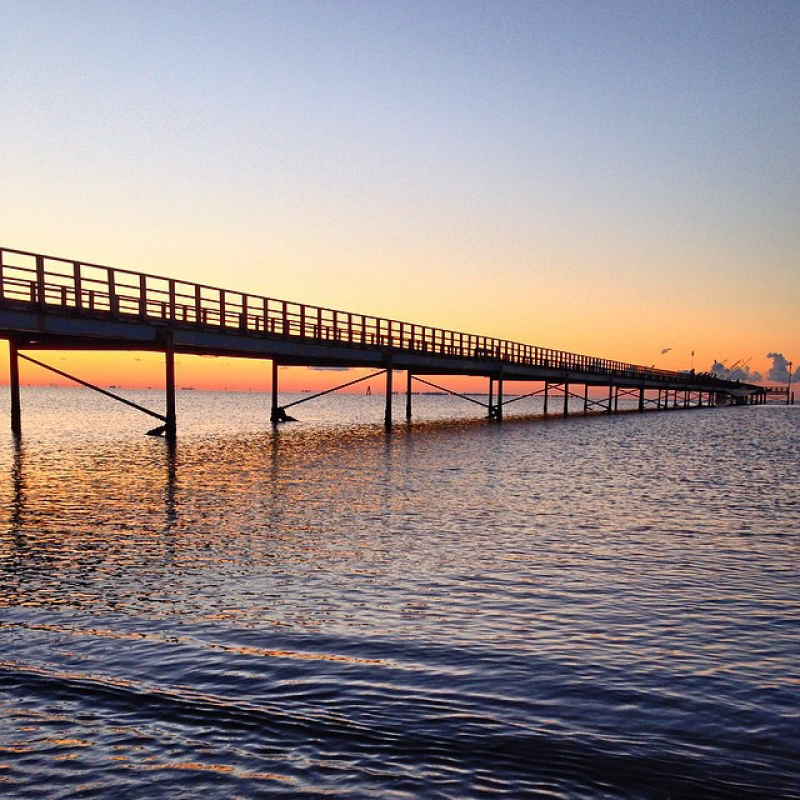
left=0, top=0, right=800, bottom=388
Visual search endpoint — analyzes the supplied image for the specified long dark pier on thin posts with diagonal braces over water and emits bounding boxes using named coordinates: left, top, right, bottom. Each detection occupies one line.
left=0, top=247, right=766, bottom=437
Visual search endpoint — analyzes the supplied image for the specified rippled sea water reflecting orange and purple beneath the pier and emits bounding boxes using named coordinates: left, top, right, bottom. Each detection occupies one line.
left=0, top=389, right=800, bottom=800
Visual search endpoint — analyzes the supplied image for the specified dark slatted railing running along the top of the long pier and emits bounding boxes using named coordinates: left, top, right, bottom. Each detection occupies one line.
left=0, top=248, right=728, bottom=384
